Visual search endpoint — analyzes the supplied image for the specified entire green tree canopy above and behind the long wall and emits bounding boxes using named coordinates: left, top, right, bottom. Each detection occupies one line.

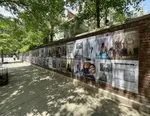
left=0, top=0, right=146, bottom=52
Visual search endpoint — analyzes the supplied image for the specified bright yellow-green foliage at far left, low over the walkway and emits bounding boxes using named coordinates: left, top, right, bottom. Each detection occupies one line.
left=0, top=15, right=44, bottom=52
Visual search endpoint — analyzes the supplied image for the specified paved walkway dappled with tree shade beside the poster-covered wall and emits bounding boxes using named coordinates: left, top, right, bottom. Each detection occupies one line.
left=0, top=63, right=146, bottom=116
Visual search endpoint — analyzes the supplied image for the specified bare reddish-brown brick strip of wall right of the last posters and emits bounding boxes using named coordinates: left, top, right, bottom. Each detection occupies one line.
left=139, top=20, right=150, bottom=100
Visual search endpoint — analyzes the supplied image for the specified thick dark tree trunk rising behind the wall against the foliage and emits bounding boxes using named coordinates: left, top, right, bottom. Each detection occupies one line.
left=96, top=0, right=100, bottom=28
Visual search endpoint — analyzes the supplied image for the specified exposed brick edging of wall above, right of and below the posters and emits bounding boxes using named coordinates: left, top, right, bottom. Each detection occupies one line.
left=29, top=15, right=150, bottom=103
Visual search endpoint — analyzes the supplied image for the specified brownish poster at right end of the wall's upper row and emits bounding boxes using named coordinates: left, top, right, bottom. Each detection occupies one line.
left=112, top=30, right=139, bottom=60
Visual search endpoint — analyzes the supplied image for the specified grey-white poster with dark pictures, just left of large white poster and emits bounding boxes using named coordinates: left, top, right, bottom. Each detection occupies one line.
left=95, top=60, right=113, bottom=84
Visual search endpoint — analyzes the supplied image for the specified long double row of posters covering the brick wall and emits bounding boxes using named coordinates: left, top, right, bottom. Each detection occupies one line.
left=26, top=30, right=139, bottom=93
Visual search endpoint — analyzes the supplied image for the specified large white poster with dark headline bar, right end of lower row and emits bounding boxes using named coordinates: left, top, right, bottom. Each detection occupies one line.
left=112, top=60, right=139, bottom=93
